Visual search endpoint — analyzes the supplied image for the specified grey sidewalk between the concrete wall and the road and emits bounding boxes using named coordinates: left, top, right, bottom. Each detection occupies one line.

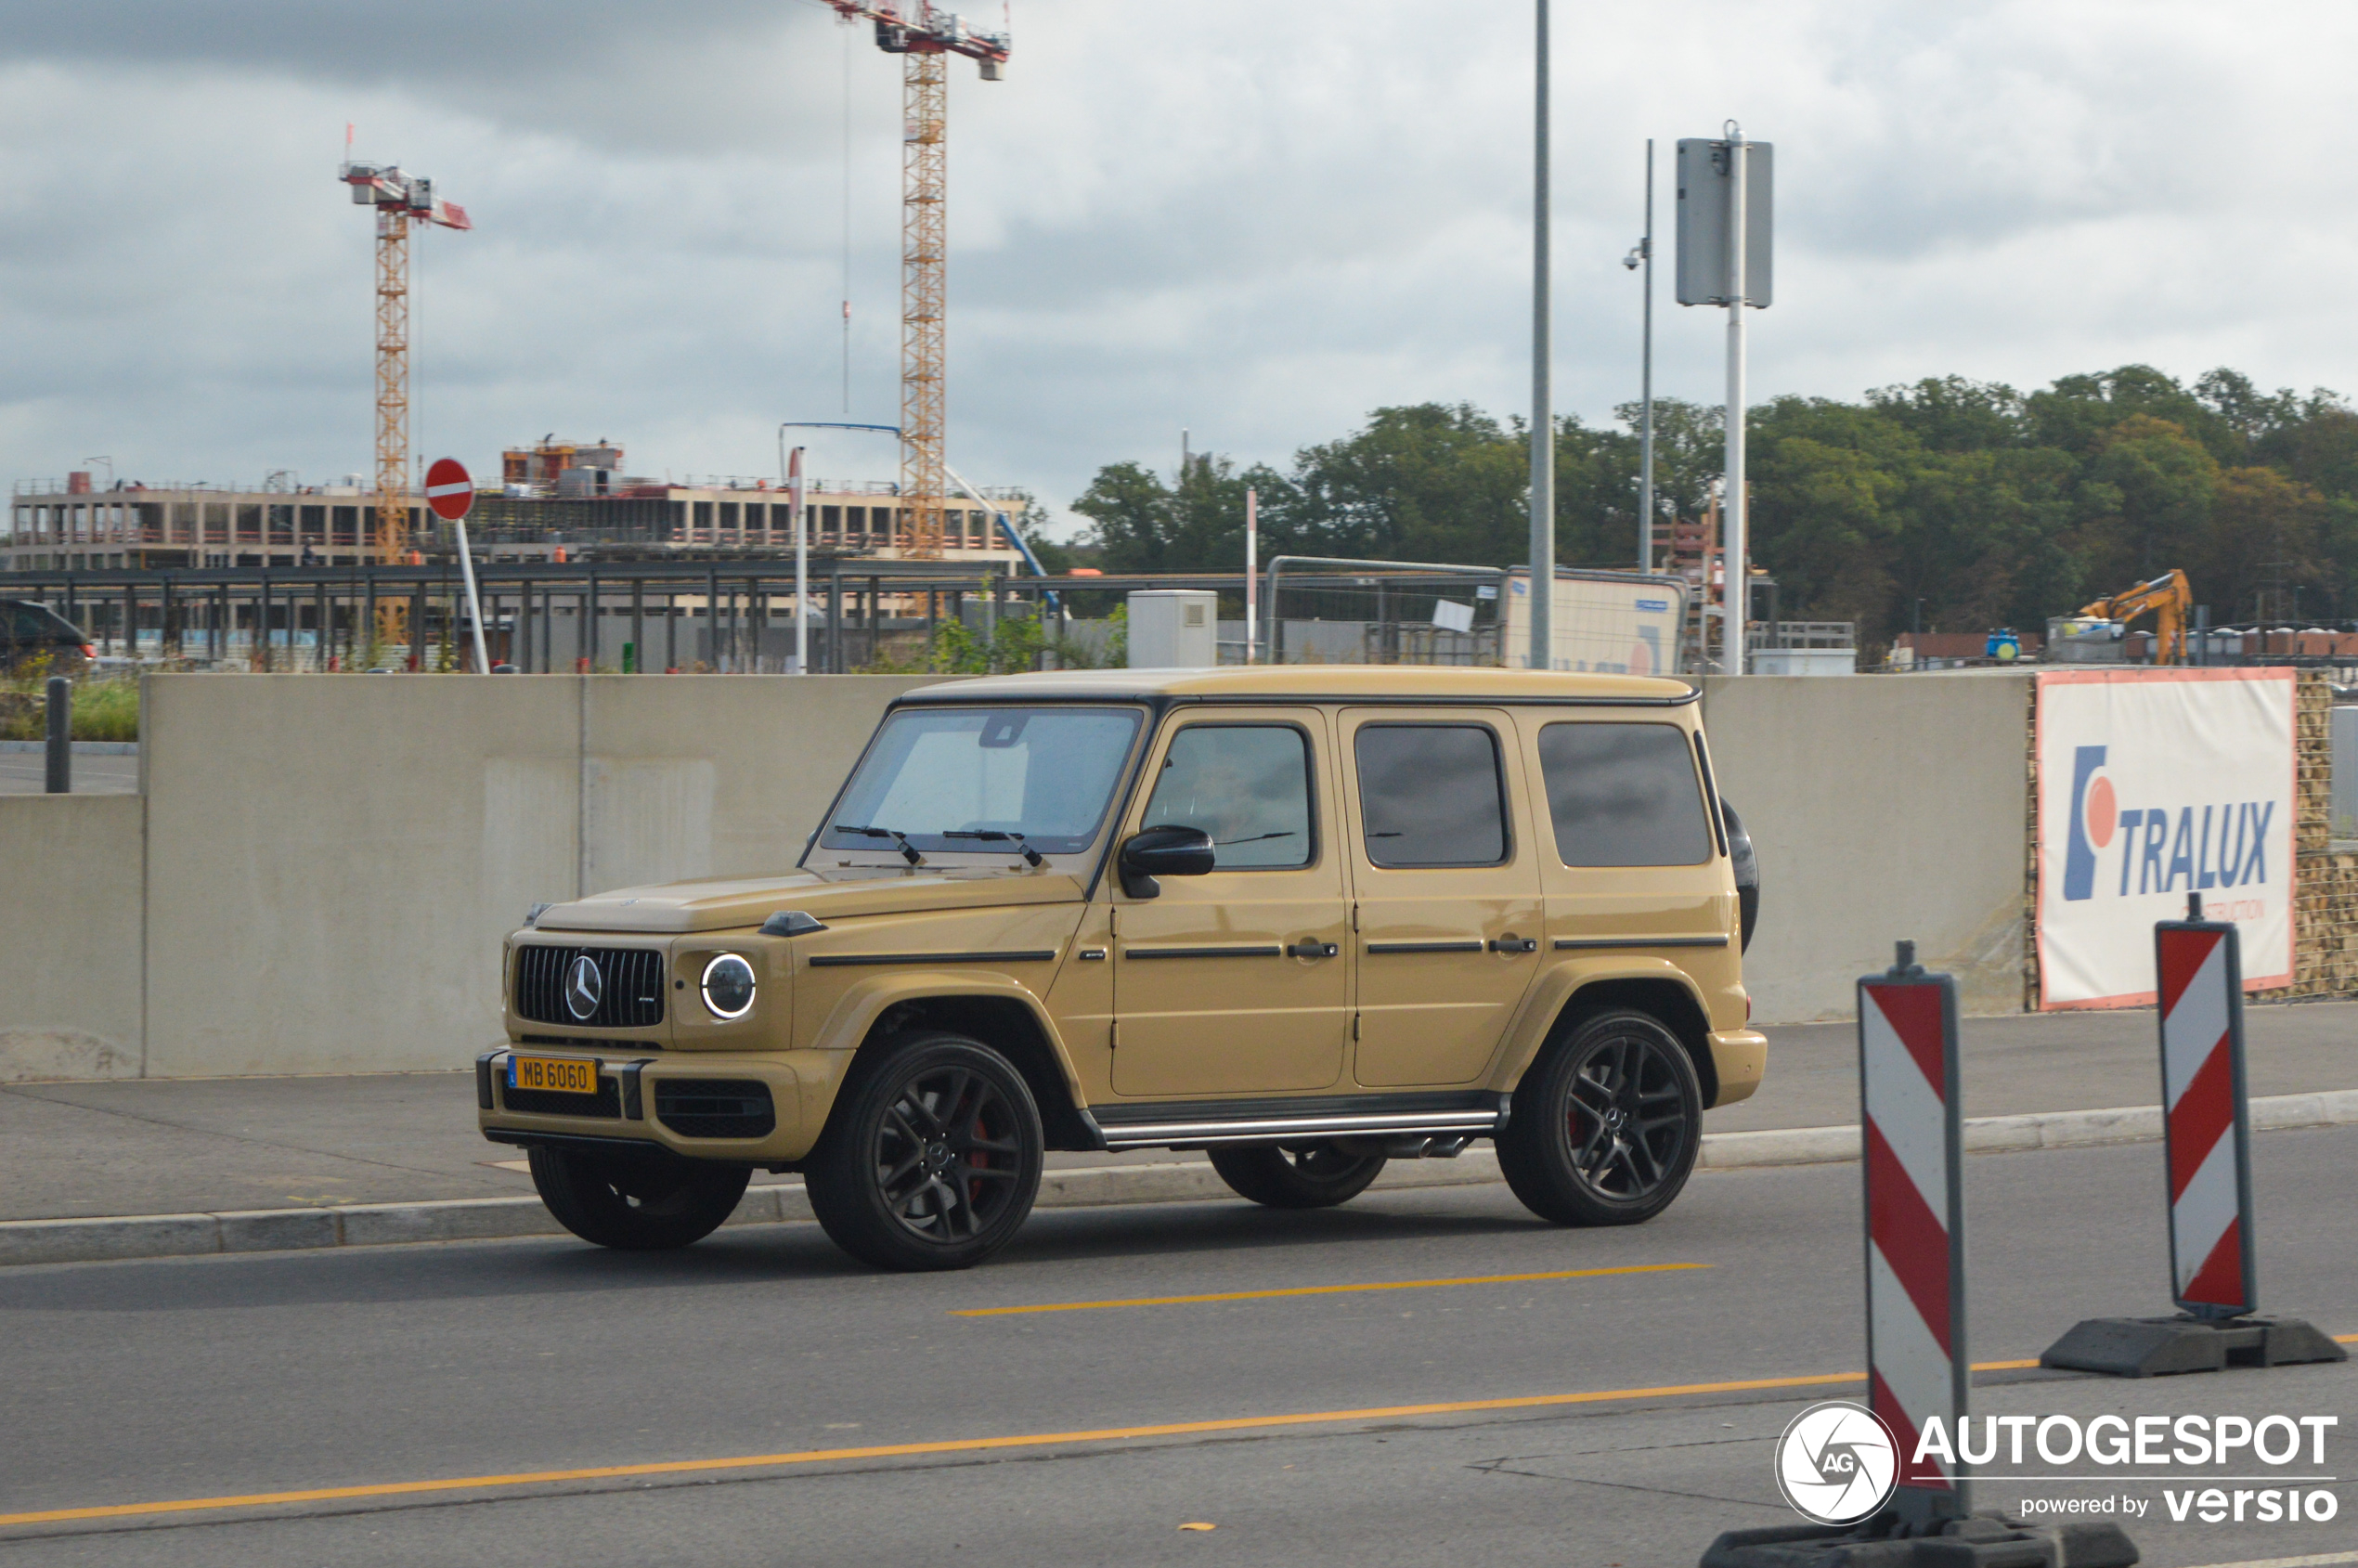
left=0, top=1002, right=2358, bottom=1254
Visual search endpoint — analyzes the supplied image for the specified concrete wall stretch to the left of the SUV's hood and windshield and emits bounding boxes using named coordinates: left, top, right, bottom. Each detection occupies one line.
left=0, top=674, right=926, bottom=1080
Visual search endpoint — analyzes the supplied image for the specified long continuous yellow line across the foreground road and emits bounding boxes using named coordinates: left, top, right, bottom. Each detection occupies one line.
left=0, top=1360, right=2066, bottom=1525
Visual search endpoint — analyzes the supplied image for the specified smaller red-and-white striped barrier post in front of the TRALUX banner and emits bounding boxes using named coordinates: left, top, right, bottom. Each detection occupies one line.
left=2153, top=905, right=2259, bottom=1318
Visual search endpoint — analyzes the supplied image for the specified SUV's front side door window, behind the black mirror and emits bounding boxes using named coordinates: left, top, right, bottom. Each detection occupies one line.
left=1141, top=724, right=1318, bottom=870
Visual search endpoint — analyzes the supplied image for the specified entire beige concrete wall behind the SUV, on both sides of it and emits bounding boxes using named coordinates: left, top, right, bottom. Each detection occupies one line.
left=0, top=674, right=2026, bottom=1080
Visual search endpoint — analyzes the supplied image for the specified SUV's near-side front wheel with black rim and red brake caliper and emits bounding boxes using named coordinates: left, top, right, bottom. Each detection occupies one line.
left=802, top=1032, right=1047, bottom=1271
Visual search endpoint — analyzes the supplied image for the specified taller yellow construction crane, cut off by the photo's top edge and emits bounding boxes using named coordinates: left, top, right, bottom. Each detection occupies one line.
left=828, top=0, right=1009, bottom=559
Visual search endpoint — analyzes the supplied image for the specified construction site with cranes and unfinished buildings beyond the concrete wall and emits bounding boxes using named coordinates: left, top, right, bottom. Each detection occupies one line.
left=0, top=0, right=2358, bottom=679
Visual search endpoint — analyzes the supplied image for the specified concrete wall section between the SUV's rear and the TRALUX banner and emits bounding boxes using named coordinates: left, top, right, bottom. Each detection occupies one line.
left=1703, top=672, right=2030, bottom=1023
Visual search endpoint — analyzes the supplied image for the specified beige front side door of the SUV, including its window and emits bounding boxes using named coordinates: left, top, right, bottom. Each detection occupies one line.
left=1110, top=707, right=1351, bottom=1099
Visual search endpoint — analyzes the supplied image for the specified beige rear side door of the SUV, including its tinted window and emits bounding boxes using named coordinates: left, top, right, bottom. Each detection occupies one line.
left=1340, top=707, right=1542, bottom=1089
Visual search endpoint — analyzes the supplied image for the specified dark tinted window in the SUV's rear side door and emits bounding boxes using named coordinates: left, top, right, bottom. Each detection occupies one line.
left=1358, top=724, right=1507, bottom=868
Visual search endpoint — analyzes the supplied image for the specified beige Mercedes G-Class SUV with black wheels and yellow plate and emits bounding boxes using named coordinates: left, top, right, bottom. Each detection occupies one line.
left=476, top=665, right=1768, bottom=1268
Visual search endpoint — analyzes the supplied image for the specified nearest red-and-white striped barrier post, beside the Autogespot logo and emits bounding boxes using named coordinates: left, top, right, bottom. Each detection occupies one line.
left=1859, top=940, right=1971, bottom=1523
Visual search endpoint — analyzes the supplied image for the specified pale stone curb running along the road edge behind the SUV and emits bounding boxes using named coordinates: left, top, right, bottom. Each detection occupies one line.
left=0, top=1089, right=2358, bottom=1266
